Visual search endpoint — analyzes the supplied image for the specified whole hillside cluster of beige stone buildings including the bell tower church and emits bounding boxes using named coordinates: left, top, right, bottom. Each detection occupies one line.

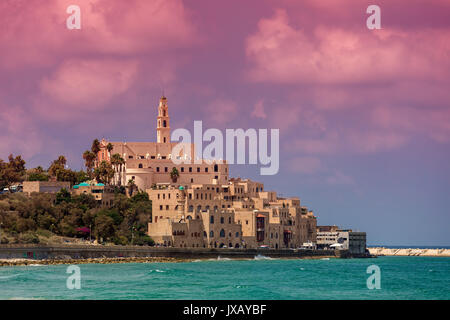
left=99, top=97, right=316, bottom=249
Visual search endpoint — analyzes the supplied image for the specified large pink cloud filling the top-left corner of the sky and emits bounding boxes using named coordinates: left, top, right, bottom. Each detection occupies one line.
left=0, top=0, right=198, bottom=68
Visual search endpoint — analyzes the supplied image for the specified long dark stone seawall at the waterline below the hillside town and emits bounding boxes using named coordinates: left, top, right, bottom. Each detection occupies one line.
left=0, top=245, right=344, bottom=260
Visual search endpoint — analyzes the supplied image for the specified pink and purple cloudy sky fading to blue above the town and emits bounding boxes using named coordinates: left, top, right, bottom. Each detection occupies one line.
left=0, top=0, right=450, bottom=245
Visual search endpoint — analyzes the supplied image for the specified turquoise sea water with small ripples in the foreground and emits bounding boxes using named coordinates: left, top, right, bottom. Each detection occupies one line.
left=0, top=257, right=450, bottom=300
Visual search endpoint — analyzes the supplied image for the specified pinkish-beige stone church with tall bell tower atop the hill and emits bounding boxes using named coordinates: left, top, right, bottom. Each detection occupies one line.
left=103, top=97, right=229, bottom=190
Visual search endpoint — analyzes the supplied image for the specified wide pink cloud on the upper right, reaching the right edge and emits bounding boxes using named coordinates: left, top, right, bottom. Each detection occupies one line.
left=246, top=9, right=450, bottom=84
